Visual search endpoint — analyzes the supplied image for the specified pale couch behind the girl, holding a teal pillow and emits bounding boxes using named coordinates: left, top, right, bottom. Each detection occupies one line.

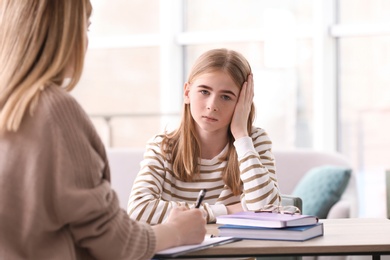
left=107, top=148, right=357, bottom=218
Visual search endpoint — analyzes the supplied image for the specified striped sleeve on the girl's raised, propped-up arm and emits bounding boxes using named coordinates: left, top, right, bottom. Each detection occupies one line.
left=234, top=128, right=280, bottom=211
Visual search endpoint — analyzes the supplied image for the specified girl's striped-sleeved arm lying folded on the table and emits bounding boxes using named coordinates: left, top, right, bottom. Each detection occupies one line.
left=127, top=137, right=222, bottom=224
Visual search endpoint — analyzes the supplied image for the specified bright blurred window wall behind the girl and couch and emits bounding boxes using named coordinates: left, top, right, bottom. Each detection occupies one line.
left=72, top=0, right=390, bottom=217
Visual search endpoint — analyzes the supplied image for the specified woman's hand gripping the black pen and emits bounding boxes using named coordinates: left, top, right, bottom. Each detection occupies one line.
left=153, top=207, right=206, bottom=252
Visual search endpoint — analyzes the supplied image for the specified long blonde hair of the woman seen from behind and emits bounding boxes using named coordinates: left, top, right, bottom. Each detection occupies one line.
left=0, top=0, right=92, bottom=131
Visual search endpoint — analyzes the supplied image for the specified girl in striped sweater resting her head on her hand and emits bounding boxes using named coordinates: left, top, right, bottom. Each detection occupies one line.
left=128, top=49, right=280, bottom=224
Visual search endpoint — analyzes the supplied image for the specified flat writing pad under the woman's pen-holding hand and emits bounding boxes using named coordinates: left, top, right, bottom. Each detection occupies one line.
left=153, top=237, right=241, bottom=259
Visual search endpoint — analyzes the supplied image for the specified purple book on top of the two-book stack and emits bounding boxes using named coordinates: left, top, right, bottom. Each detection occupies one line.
left=216, top=211, right=318, bottom=228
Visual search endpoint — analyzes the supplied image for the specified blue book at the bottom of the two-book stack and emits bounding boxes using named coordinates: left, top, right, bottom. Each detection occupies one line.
left=218, top=223, right=324, bottom=241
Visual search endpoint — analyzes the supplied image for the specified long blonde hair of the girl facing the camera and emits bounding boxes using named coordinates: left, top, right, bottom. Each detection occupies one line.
left=162, top=49, right=255, bottom=195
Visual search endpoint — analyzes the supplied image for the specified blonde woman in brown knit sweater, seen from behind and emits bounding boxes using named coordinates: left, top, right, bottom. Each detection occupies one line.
left=0, top=0, right=206, bottom=259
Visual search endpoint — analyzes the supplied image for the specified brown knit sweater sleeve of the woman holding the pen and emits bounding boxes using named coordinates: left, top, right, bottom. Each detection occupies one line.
left=43, top=88, right=156, bottom=259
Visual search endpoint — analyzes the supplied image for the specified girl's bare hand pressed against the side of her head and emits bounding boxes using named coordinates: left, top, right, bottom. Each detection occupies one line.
left=230, top=74, right=254, bottom=140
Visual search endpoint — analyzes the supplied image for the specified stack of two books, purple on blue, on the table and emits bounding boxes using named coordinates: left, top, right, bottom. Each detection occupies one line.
left=216, top=211, right=324, bottom=241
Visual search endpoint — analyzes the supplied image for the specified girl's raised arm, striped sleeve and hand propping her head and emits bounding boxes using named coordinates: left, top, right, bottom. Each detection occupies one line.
left=228, top=74, right=280, bottom=212
